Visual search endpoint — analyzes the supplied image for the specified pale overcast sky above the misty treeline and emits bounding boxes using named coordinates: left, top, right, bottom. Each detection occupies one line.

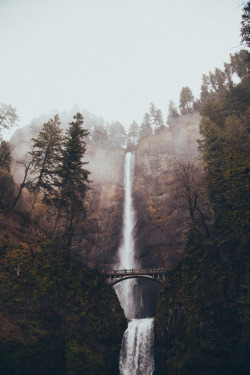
left=0, top=0, right=245, bottom=134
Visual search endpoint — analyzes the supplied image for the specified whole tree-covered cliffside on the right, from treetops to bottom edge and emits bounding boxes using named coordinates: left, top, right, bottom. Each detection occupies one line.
left=155, top=4, right=250, bottom=375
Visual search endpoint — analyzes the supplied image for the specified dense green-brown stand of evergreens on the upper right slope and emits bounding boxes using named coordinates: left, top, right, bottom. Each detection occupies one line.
left=199, top=51, right=250, bottom=238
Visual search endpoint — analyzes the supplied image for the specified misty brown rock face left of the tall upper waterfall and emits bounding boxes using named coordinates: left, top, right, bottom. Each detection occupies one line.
left=77, top=148, right=124, bottom=268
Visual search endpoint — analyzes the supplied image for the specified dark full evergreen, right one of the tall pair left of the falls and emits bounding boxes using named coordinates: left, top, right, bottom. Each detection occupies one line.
left=52, top=113, right=90, bottom=246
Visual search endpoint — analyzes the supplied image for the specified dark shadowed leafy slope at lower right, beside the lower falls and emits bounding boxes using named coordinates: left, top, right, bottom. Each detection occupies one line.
left=155, top=241, right=250, bottom=375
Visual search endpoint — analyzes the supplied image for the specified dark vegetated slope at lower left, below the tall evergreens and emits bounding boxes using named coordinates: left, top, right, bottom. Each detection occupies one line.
left=0, top=211, right=126, bottom=375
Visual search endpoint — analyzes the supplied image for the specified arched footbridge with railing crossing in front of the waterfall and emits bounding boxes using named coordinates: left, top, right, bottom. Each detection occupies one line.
left=100, top=268, right=167, bottom=286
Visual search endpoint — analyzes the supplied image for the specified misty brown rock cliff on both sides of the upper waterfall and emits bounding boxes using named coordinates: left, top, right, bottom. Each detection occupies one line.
left=78, top=113, right=200, bottom=268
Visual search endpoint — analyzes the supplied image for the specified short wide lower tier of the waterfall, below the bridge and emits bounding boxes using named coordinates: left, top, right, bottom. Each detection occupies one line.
left=119, top=318, right=154, bottom=375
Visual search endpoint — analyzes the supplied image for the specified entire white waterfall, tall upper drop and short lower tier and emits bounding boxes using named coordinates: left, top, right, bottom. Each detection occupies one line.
left=114, top=152, right=154, bottom=375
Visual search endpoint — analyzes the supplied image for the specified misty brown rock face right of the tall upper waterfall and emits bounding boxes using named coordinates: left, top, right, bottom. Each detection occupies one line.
left=133, top=113, right=200, bottom=268
